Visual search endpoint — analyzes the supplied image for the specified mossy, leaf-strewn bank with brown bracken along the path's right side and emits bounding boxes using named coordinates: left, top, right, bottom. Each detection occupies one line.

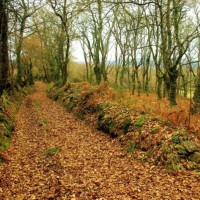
left=48, top=83, right=200, bottom=171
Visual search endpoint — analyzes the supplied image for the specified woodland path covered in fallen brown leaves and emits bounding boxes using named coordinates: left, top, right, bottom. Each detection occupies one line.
left=0, top=83, right=200, bottom=200
